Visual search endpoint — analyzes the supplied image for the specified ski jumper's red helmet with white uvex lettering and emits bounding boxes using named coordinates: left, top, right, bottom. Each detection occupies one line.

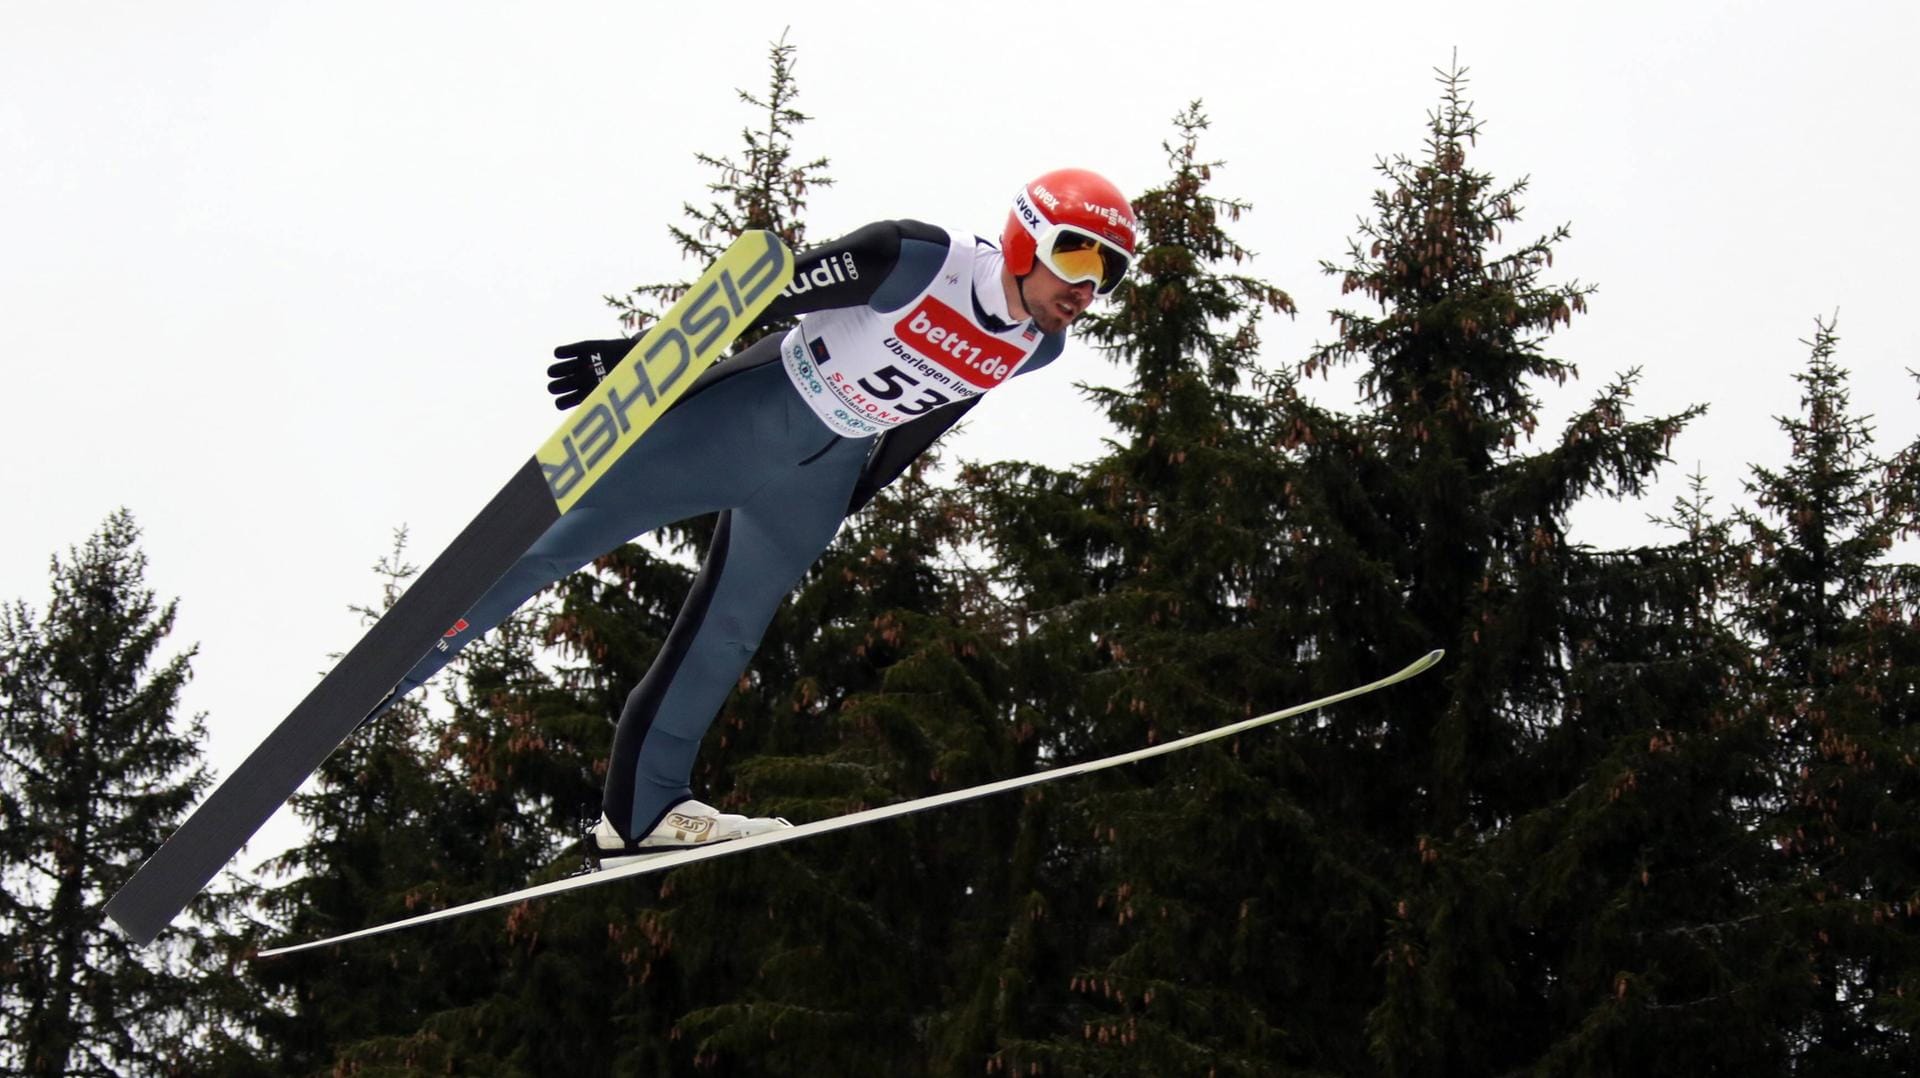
left=1000, top=169, right=1135, bottom=296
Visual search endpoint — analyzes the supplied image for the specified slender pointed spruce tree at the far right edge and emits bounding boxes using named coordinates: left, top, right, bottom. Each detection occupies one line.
left=1738, top=321, right=1920, bottom=1076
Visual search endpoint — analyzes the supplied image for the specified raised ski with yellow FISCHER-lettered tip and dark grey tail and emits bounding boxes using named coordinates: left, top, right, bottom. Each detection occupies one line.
left=106, top=231, right=793, bottom=943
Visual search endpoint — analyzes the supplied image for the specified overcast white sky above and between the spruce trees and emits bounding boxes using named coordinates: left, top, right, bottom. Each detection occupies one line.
left=0, top=0, right=1920, bottom=864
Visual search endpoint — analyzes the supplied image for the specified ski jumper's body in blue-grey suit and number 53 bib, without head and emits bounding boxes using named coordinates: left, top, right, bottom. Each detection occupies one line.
left=378, top=221, right=1064, bottom=838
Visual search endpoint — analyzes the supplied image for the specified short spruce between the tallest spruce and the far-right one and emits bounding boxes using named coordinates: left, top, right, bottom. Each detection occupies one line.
left=1505, top=478, right=1797, bottom=1074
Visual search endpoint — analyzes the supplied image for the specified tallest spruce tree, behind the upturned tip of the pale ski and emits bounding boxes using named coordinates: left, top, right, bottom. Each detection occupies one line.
left=1228, top=67, right=1697, bottom=1074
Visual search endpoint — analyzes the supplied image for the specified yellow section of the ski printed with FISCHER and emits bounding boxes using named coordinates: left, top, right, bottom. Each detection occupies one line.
left=534, top=231, right=793, bottom=513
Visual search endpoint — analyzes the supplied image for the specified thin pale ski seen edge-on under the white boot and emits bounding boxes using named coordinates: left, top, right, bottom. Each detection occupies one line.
left=255, top=651, right=1444, bottom=959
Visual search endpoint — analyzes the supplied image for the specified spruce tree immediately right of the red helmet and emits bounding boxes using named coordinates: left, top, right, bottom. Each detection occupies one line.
left=948, top=102, right=1304, bottom=1074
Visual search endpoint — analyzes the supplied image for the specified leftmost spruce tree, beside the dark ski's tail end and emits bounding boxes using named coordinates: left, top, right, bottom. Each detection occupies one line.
left=0, top=509, right=215, bottom=1074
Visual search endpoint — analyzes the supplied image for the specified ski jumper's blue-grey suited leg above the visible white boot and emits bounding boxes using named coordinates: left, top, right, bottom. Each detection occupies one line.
left=603, top=428, right=872, bottom=838
